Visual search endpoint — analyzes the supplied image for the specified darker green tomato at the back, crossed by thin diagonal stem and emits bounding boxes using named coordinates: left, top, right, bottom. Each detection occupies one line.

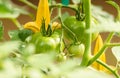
left=64, top=16, right=85, bottom=42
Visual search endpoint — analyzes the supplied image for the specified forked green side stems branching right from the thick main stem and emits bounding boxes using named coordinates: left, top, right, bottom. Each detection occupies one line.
left=87, top=32, right=120, bottom=78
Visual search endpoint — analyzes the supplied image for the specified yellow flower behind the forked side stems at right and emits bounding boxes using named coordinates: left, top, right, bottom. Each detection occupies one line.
left=92, top=35, right=106, bottom=71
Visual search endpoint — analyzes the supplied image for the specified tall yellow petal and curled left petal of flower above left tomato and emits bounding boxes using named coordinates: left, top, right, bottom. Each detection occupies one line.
left=24, top=0, right=50, bottom=32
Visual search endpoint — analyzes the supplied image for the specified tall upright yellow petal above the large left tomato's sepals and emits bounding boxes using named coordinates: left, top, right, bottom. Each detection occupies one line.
left=35, top=0, right=50, bottom=29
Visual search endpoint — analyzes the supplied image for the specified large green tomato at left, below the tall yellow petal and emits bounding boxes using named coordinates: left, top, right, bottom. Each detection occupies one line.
left=30, top=31, right=64, bottom=53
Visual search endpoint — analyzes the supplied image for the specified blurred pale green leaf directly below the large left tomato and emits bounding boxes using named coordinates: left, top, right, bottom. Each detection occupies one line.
left=28, top=53, right=54, bottom=69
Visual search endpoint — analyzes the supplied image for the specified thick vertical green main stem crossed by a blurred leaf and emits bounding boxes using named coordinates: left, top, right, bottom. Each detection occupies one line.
left=81, top=0, right=91, bottom=66
